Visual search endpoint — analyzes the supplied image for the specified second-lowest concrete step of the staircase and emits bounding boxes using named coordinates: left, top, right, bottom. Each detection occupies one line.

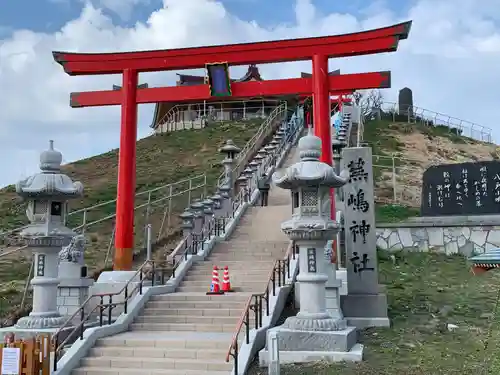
left=80, top=357, right=233, bottom=372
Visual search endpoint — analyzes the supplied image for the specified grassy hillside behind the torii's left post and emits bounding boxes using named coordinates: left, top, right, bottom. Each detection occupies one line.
left=0, top=120, right=262, bottom=324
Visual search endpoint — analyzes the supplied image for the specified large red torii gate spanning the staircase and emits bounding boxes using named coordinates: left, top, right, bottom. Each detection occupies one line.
left=53, top=21, right=411, bottom=271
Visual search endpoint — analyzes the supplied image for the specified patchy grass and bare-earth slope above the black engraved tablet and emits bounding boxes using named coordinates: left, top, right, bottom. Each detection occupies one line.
left=364, top=120, right=499, bottom=222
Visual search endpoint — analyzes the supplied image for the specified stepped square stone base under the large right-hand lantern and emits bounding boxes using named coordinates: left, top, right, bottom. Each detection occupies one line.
left=259, top=326, right=364, bottom=367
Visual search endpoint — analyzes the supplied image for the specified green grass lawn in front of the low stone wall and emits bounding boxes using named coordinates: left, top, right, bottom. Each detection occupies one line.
left=249, top=252, right=500, bottom=375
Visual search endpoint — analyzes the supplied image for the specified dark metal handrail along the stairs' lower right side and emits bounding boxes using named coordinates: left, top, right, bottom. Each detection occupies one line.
left=226, top=241, right=299, bottom=375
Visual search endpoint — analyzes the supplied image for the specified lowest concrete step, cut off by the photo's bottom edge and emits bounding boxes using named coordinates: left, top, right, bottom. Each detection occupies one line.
left=71, top=368, right=232, bottom=375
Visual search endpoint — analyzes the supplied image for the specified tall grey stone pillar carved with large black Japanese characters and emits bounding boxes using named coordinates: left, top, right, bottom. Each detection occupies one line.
left=342, top=147, right=390, bottom=328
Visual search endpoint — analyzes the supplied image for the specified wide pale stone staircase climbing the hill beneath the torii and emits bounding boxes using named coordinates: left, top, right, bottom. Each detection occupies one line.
left=72, top=149, right=295, bottom=375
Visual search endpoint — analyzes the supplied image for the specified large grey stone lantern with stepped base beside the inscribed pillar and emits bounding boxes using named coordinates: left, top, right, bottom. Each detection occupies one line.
left=262, top=129, right=362, bottom=363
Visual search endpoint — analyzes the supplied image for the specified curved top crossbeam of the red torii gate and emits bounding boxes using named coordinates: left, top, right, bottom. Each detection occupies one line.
left=53, top=21, right=411, bottom=76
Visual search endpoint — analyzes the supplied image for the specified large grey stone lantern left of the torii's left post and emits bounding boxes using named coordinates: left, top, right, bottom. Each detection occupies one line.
left=16, top=141, right=83, bottom=329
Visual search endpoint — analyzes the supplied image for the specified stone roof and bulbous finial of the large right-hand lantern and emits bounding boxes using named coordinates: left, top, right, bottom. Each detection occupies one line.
left=273, top=129, right=349, bottom=190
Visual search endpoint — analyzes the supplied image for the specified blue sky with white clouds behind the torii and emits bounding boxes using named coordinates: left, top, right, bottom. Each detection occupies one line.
left=0, top=0, right=500, bottom=186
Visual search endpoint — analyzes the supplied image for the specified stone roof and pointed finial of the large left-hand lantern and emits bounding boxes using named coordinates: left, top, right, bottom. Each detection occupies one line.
left=16, top=140, right=83, bottom=200
